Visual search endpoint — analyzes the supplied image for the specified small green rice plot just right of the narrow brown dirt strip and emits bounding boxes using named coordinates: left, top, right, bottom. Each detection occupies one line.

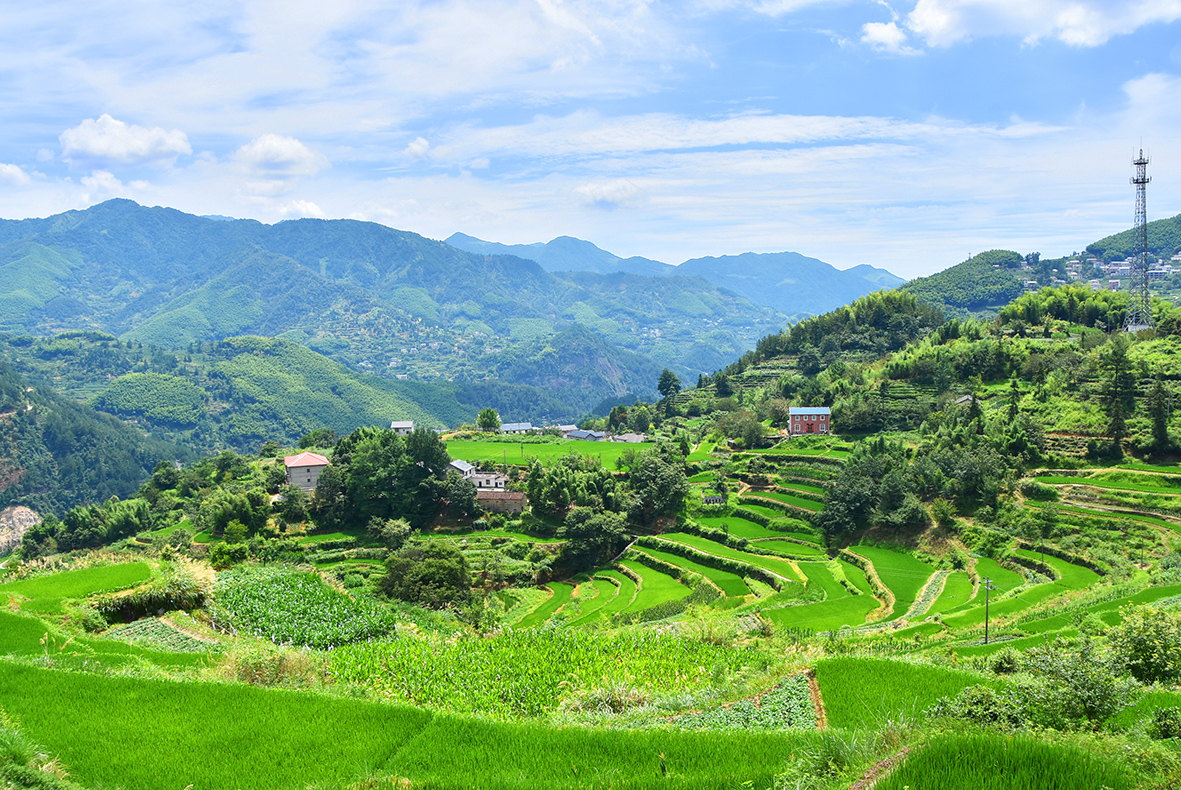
left=815, top=658, right=997, bottom=730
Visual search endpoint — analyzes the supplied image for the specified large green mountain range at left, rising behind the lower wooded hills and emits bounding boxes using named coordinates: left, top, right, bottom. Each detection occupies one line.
left=0, top=200, right=785, bottom=419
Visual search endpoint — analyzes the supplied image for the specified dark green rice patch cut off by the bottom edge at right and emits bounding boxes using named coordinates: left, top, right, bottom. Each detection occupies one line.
left=874, top=733, right=1136, bottom=790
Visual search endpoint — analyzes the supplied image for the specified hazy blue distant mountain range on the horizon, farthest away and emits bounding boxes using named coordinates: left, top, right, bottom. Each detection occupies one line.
left=446, top=233, right=906, bottom=318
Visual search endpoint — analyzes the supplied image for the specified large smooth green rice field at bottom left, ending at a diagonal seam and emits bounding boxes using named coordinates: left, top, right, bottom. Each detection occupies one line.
left=0, top=662, right=430, bottom=790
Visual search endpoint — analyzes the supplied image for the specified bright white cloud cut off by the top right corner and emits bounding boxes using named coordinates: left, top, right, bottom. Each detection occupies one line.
left=906, top=0, right=1181, bottom=46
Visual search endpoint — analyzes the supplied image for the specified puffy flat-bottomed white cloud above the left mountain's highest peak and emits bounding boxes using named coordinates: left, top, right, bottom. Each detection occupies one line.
left=58, top=113, right=193, bottom=165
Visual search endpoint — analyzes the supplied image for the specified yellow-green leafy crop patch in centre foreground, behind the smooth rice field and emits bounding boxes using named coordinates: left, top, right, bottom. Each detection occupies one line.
left=331, top=628, right=772, bottom=718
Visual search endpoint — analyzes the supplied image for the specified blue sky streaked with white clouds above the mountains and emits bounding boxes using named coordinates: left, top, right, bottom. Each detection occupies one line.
left=0, top=0, right=1181, bottom=276
